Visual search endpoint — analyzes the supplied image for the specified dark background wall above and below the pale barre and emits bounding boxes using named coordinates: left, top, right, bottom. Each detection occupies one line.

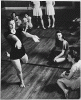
left=1, top=1, right=80, bottom=26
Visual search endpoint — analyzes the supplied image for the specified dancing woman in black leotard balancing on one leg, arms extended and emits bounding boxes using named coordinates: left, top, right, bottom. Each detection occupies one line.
left=4, top=19, right=39, bottom=87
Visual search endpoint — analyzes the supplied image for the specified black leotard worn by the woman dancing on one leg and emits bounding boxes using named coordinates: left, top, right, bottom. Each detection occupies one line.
left=4, top=28, right=25, bottom=60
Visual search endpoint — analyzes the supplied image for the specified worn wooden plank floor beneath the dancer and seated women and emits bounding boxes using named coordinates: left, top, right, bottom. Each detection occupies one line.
left=1, top=27, right=80, bottom=99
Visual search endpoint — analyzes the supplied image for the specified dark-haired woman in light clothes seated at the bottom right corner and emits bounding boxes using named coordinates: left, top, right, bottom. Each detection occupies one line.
left=57, top=50, right=81, bottom=98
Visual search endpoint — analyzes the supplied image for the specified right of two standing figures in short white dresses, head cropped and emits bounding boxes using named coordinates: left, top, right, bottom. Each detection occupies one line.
left=46, top=1, right=55, bottom=28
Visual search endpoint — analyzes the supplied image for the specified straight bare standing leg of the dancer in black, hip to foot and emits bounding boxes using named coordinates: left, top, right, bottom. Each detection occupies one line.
left=11, top=59, right=25, bottom=87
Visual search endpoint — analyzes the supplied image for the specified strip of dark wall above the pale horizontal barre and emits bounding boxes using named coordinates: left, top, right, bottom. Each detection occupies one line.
left=1, top=1, right=76, bottom=7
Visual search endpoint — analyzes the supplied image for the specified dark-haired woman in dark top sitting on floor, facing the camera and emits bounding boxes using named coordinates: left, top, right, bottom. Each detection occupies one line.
left=48, top=31, right=69, bottom=63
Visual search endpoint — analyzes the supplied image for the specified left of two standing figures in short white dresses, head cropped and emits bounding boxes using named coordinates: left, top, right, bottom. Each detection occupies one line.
left=33, top=1, right=46, bottom=29
